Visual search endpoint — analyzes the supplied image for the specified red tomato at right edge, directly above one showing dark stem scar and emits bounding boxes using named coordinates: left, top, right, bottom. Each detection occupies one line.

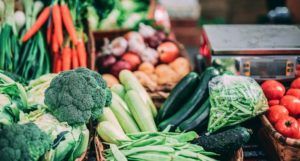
left=280, top=95, right=300, bottom=116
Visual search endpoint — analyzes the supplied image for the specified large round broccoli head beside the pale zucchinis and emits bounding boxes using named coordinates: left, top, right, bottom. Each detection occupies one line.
left=45, top=68, right=111, bottom=126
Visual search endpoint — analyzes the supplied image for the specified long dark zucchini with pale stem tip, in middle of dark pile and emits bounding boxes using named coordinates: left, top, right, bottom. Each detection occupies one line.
left=158, top=67, right=219, bottom=130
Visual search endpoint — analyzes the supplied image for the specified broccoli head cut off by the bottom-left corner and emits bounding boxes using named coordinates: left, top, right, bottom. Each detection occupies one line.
left=0, top=123, right=51, bottom=161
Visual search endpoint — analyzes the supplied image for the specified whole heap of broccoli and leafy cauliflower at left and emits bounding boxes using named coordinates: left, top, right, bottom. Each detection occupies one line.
left=0, top=68, right=112, bottom=161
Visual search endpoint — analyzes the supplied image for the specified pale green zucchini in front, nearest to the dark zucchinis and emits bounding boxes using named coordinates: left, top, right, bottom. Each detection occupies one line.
left=125, top=90, right=157, bottom=132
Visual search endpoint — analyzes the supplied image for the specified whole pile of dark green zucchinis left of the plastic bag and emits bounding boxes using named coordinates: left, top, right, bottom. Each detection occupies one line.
left=157, top=67, right=219, bottom=132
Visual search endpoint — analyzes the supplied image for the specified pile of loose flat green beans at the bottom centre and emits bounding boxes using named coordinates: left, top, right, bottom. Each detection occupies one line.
left=105, top=132, right=218, bottom=161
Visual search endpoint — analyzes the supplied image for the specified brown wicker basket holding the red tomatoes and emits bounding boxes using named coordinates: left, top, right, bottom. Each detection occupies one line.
left=259, top=115, right=300, bottom=161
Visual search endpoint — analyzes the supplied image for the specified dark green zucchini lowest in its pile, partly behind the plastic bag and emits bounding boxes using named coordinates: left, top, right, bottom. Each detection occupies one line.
left=178, top=99, right=210, bottom=132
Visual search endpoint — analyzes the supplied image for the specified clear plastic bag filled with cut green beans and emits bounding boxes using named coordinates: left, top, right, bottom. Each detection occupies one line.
left=208, top=74, right=268, bottom=132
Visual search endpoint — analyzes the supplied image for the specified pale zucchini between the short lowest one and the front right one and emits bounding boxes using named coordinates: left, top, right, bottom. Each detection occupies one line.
left=109, top=92, right=140, bottom=133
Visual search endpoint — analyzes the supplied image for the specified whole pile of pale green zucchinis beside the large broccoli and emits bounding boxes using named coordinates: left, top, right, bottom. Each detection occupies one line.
left=97, top=70, right=157, bottom=140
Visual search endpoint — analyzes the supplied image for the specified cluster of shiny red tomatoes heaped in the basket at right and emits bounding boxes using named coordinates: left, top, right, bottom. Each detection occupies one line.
left=261, top=78, right=300, bottom=139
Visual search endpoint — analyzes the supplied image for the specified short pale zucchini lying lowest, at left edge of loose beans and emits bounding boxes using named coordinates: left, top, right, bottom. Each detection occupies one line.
left=96, top=121, right=130, bottom=145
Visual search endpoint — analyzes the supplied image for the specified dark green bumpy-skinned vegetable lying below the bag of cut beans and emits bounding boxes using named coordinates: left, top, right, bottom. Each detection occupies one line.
left=193, top=127, right=250, bottom=155
